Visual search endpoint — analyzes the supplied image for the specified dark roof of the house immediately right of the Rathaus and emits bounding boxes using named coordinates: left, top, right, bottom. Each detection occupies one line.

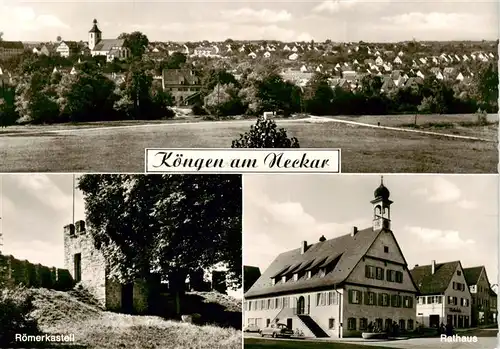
left=410, top=261, right=460, bottom=295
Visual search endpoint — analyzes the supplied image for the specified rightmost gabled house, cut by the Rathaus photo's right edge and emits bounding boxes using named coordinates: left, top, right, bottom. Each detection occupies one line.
left=464, top=266, right=497, bottom=326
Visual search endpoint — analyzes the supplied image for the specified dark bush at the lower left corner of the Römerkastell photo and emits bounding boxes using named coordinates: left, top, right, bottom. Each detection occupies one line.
left=0, top=287, right=40, bottom=348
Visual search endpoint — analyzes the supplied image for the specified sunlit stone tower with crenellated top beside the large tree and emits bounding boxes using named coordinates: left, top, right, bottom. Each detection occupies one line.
left=64, top=221, right=107, bottom=307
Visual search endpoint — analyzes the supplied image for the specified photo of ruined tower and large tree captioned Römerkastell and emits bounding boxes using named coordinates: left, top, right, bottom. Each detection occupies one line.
left=0, top=174, right=242, bottom=349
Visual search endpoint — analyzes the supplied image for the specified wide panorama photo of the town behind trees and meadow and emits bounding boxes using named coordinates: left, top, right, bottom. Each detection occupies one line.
left=0, top=0, right=498, bottom=173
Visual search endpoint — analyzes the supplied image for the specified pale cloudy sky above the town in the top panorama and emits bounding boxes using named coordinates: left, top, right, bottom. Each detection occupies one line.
left=0, top=0, right=499, bottom=41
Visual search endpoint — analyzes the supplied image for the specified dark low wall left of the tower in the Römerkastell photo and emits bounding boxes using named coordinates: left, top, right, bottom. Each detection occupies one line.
left=0, top=254, right=73, bottom=291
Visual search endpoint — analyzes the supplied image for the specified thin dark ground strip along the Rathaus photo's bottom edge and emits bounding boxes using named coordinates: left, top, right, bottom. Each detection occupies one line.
left=244, top=338, right=394, bottom=349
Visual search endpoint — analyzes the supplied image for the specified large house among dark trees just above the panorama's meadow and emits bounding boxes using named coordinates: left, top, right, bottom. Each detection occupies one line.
left=162, top=69, right=202, bottom=106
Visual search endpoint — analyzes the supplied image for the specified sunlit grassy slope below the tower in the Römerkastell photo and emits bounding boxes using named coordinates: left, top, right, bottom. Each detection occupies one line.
left=25, top=289, right=242, bottom=349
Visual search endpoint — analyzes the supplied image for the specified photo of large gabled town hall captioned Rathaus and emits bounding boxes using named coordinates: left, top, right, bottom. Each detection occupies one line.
left=243, top=175, right=499, bottom=349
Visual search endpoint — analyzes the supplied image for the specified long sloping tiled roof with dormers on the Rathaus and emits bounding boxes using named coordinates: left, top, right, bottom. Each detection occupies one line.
left=245, top=227, right=382, bottom=298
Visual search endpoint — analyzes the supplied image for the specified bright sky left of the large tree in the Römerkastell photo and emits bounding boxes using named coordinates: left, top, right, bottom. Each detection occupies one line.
left=0, top=174, right=85, bottom=268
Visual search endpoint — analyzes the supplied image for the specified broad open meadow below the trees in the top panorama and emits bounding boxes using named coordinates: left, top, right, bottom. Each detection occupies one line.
left=0, top=115, right=498, bottom=173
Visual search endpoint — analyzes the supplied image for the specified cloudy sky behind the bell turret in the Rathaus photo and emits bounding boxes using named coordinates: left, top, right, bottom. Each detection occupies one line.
left=243, top=175, right=499, bottom=284
